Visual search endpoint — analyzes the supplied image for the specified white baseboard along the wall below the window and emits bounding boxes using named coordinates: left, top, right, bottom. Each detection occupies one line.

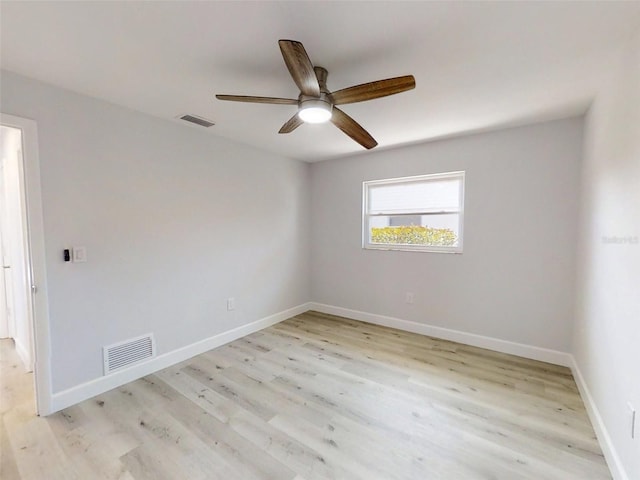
left=309, top=302, right=572, bottom=367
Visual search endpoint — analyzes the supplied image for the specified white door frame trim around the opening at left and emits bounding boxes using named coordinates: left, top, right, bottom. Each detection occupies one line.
left=0, top=113, right=52, bottom=416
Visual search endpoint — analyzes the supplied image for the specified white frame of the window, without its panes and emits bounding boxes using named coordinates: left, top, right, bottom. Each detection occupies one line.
left=362, top=170, right=465, bottom=254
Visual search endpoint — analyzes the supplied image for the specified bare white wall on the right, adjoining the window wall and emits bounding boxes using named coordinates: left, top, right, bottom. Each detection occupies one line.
left=573, top=27, right=640, bottom=479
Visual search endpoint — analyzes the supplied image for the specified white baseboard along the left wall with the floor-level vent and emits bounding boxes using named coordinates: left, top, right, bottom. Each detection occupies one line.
left=47, top=303, right=309, bottom=414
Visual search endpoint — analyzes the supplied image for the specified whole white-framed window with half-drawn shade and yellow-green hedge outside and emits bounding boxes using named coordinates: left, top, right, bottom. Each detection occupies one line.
left=362, top=172, right=464, bottom=253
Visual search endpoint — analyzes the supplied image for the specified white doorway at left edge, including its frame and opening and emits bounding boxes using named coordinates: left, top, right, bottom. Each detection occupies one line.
left=0, top=114, right=51, bottom=415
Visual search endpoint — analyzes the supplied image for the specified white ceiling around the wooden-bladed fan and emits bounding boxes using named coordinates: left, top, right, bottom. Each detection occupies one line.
left=0, top=1, right=640, bottom=161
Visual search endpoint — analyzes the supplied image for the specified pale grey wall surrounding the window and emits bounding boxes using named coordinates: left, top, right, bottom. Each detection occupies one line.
left=311, top=118, right=582, bottom=352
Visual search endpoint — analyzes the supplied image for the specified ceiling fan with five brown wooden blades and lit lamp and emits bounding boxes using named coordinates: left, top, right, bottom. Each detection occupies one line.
left=216, top=40, right=416, bottom=149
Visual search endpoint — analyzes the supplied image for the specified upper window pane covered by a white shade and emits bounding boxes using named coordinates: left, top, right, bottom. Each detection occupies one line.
left=369, top=178, right=461, bottom=215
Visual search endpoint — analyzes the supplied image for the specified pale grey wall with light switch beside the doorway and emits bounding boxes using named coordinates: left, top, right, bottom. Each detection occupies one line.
left=0, top=72, right=310, bottom=393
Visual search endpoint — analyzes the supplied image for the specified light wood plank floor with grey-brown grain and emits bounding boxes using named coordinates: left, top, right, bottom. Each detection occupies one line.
left=0, top=312, right=611, bottom=480
